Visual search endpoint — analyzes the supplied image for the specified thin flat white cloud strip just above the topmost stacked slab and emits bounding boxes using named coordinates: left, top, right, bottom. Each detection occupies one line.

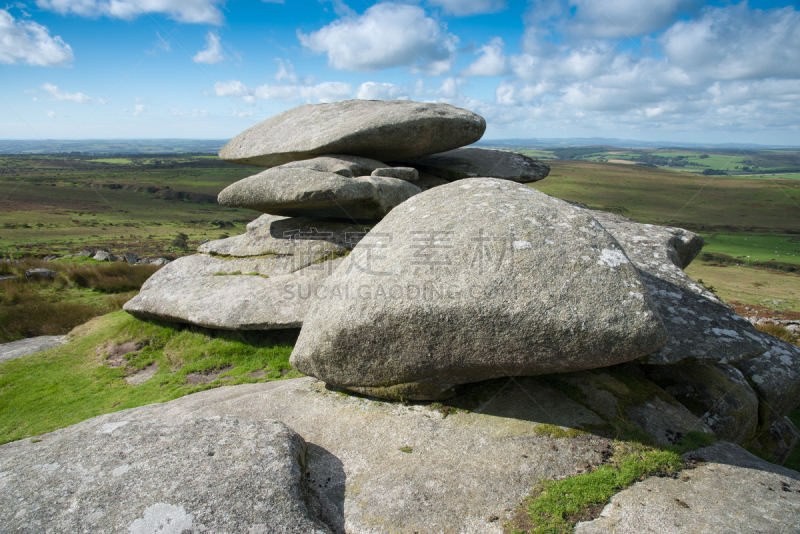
left=214, top=80, right=353, bottom=104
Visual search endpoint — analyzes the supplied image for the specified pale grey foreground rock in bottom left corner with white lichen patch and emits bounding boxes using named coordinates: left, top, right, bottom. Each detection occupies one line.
left=0, top=416, right=330, bottom=534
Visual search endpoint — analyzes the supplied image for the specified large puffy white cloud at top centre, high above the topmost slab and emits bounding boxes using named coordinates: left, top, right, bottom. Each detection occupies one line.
left=297, top=3, right=458, bottom=76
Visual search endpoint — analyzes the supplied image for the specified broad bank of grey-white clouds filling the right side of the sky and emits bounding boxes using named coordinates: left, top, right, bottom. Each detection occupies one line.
left=482, top=0, right=800, bottom=139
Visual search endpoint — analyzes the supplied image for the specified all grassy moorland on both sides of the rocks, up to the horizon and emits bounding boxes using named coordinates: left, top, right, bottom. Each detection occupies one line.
left=0, top=143, right=800, bottom=532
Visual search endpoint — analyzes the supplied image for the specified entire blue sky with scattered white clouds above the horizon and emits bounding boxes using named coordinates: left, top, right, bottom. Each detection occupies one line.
left=0, top=0, right=800, bottom=145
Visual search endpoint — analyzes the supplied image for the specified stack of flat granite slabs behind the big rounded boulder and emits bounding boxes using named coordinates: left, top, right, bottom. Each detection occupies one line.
left=125, top=100, right=549, bottom=330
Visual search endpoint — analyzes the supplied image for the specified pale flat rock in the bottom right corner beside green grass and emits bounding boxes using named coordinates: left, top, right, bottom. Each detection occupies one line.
left=575, top=442, right=800, bottom=534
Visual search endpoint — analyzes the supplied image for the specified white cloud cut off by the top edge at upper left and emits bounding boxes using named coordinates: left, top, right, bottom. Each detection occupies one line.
left=36, top=0, right=225, bottom=24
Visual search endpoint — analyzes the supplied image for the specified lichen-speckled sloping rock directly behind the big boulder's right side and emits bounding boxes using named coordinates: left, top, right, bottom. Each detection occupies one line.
left=588, top=210, right=767, bottom=364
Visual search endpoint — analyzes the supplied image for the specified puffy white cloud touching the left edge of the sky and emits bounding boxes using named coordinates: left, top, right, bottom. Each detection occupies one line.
left=0, top=9, right=74, bottom=67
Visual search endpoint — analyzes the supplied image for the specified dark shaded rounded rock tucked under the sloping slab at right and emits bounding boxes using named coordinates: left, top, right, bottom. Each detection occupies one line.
left=638, top=365, right=758, bottom=445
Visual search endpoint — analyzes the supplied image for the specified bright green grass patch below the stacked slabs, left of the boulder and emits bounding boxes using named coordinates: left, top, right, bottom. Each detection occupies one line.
left=0, top=311, right=301, bottom=444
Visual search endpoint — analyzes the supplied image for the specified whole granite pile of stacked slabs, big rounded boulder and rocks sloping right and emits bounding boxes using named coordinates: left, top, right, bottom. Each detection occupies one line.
left=120, top=101, right=800, bottom=461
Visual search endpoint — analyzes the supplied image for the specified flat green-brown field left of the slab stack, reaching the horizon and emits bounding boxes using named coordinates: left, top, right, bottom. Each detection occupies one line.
left=0, top=154, right=261, bottom=256
